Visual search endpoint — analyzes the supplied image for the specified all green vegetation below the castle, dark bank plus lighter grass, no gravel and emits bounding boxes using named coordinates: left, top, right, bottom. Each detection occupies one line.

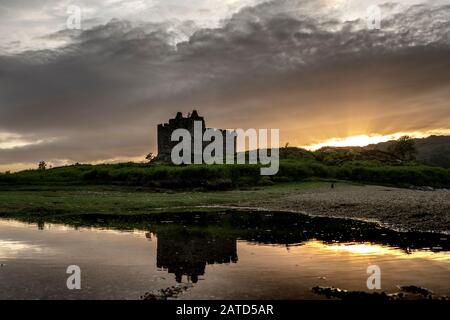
left=0, top=148, right=450, bottom=221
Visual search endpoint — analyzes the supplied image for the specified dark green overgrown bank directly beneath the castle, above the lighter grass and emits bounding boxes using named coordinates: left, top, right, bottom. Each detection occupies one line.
left=0, top=158, right=450, bottom=191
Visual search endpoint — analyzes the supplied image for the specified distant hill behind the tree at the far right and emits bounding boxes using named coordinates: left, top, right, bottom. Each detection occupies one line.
left=364, top=136, right=450, bottom=168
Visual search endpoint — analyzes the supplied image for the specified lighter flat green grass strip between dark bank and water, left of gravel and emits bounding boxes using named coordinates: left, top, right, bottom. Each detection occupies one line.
left=0, top=181, right=344, bottom=216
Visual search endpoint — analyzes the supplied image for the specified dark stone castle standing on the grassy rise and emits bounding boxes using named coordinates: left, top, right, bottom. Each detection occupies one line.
left=158, top=110, right=236, bottom=159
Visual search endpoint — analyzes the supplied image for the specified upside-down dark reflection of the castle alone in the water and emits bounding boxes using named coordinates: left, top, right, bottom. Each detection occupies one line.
left=157, top=230, right=238, bottom=283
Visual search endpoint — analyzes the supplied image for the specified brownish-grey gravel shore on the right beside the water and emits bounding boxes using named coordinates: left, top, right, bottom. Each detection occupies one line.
left=240, top=185, right=450, bottom=233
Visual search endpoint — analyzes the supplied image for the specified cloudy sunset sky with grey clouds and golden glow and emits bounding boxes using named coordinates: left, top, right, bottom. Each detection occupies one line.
left=0, top=0, right=450, bottom=171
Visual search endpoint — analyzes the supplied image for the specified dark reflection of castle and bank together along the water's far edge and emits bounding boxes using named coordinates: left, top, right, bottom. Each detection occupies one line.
left=152, top=211, right=450, bottom=283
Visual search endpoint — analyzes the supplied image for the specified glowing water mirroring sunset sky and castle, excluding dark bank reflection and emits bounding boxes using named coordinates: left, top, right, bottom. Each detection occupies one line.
left=0, top=219, right=450, bottom=299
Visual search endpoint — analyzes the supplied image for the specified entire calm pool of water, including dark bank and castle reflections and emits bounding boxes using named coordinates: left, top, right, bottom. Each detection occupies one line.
left=0, top=212, right=450, bottom=299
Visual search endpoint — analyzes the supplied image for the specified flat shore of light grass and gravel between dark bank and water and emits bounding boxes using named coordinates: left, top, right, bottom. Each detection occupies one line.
left=0, top=181, right=450, bottom=234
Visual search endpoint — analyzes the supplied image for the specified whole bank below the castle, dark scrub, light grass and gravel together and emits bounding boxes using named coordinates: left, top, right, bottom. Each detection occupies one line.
left=0, top=149, right=450, bottom=231
